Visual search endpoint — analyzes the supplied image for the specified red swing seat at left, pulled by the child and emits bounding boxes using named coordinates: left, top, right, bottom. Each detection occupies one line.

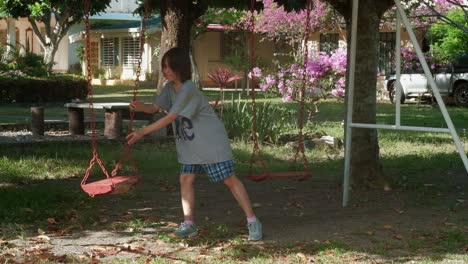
left=81, top=175, right=141, bottom=197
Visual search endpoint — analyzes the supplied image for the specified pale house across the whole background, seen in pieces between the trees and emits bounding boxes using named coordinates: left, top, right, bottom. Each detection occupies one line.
left=0, top=0, right=423, bottom=87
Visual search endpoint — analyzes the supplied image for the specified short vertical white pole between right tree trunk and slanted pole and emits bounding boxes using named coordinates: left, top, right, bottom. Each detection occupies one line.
left=393, top=12, right=402, bottom=126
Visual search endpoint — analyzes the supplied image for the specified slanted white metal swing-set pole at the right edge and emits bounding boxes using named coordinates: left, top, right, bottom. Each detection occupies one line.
left=395, top=0, right=468, bottom=172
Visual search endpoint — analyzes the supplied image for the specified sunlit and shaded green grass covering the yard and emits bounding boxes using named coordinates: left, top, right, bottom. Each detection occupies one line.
left=0, top=86, right=468, bottom=263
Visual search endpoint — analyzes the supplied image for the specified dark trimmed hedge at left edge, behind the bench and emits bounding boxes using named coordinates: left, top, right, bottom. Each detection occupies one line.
left=0, top=77, right=88, bottom=103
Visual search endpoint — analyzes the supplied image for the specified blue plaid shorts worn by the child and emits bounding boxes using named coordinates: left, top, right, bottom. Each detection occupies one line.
left=180, top=160, right=235, bottom=182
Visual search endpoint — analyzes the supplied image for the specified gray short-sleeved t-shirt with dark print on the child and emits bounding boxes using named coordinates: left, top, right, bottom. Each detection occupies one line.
left=154, top=80, right=232, bottom=164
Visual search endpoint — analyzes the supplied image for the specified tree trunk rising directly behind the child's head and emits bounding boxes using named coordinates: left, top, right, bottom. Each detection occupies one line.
left=158, top=0, right=193, bottom=90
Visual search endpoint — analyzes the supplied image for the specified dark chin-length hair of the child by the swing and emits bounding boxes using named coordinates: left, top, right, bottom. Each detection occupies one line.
left=161, top=48, right=192, bottom=82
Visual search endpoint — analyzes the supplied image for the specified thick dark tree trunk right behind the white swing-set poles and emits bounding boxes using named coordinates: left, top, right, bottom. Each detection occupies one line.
left=327, top=0, right=393, bottom=188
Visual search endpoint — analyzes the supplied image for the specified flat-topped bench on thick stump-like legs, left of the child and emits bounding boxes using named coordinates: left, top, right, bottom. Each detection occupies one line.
left=64, top=103, right=153, bottom=139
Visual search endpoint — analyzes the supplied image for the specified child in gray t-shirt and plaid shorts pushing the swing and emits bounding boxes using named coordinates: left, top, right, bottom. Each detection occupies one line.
left=126, top=48, right=262, bottom=240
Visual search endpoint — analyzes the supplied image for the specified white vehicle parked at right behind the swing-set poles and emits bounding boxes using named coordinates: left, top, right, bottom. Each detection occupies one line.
left=386, top=56, right=468, bottom=106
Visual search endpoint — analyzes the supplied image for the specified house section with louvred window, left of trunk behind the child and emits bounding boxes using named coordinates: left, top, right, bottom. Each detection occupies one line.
left=0, top=0, right=160, bottom=82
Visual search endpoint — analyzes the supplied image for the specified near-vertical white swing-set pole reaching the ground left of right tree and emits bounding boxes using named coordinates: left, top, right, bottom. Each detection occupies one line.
left=343, top=0, right=359, bottom=206
